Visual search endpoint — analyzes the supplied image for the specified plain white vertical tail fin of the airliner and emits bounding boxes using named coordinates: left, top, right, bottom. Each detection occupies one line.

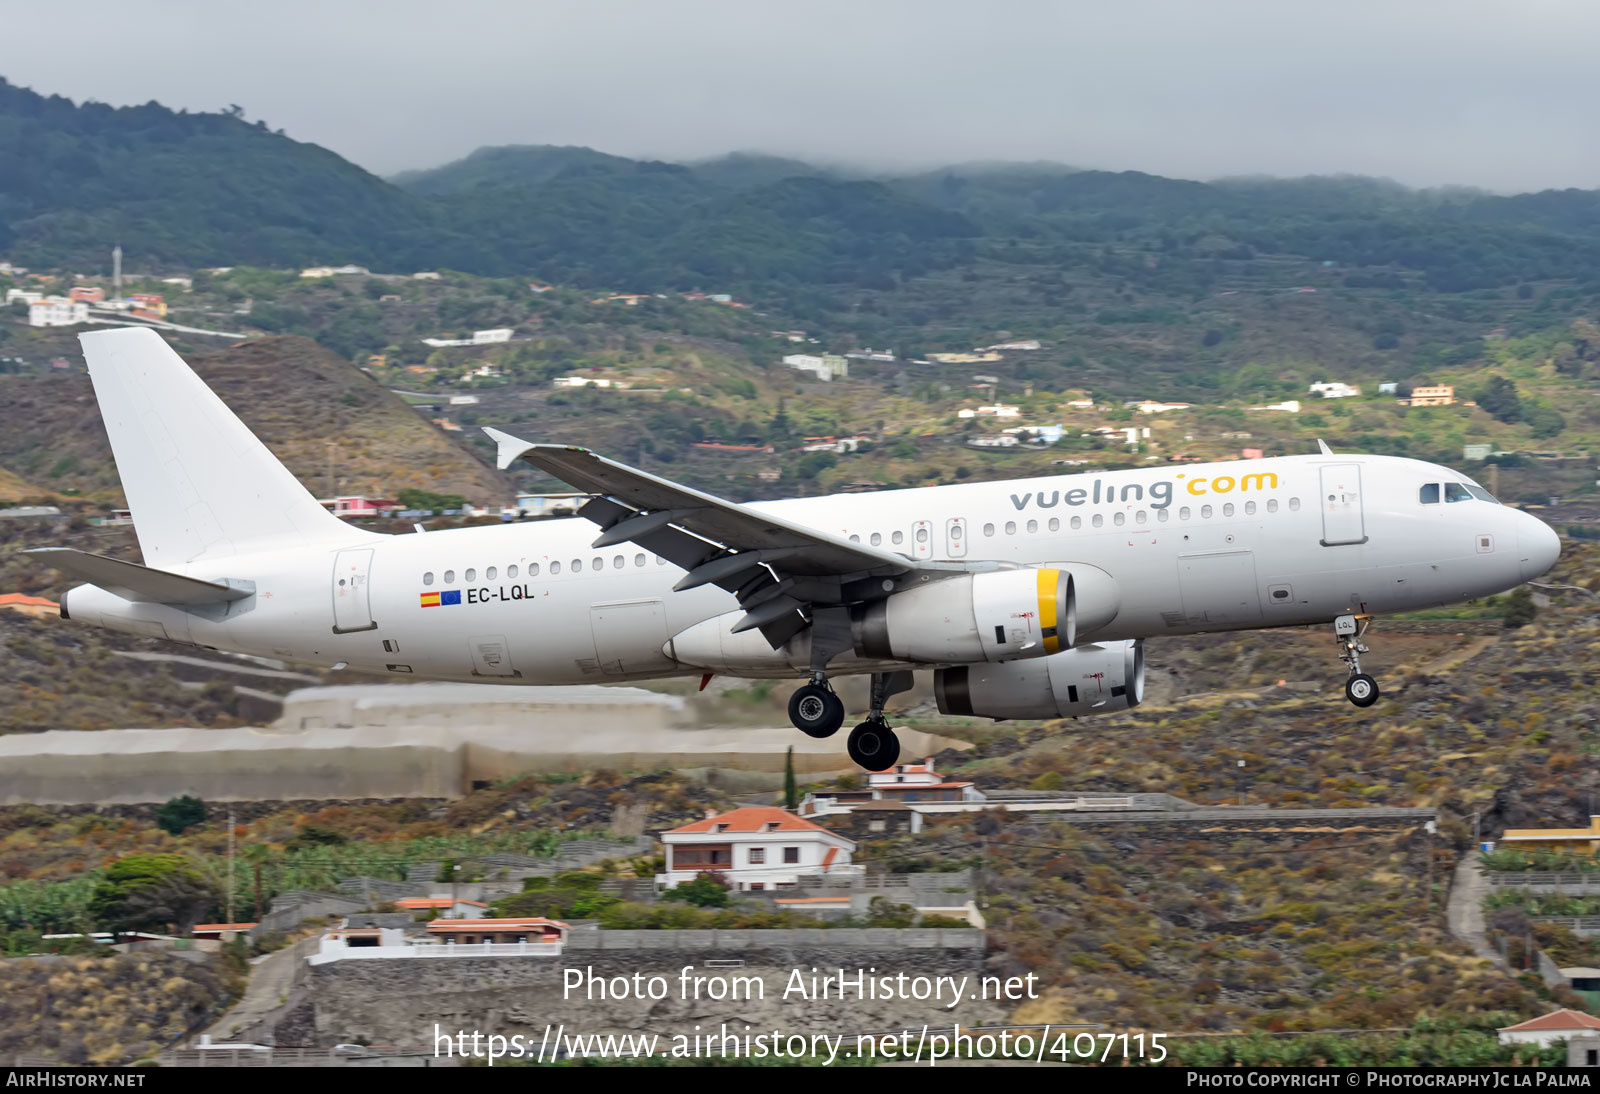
left=78, top=326, right=360, bottom=568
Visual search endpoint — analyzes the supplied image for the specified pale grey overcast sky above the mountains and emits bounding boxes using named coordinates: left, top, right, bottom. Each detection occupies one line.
left=0, top=0, right=1600, bottom=190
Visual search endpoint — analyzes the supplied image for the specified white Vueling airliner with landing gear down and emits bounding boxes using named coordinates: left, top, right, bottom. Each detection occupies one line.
left=35, top=328, right=1560, bottom=771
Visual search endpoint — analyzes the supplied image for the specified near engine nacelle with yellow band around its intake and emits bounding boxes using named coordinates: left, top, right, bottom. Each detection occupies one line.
left=851, top=568, right=1077, bottom=665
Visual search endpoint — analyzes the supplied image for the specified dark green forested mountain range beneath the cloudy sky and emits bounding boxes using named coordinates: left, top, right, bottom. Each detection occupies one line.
left=9, top=80, right=1600, bottom=302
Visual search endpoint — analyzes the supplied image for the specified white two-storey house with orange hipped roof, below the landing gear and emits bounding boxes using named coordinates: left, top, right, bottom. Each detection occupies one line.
left=656, top=806, right=862, bottom=892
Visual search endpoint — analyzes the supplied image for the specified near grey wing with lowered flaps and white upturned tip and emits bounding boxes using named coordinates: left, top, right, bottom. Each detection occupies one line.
left=483, top=429, right=942, bottom=648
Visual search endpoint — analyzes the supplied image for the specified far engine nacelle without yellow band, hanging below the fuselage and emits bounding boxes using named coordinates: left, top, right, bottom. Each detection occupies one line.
left=933, top=640, right=1144, bottom=720
